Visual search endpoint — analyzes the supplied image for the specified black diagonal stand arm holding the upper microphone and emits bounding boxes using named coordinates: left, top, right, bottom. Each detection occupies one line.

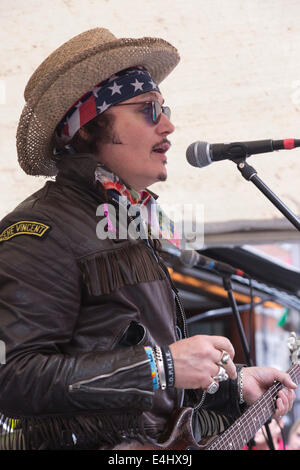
left=237, top=160, right=300, bottom=231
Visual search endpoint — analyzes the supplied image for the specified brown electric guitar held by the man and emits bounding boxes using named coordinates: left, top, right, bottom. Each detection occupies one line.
left=155, top=333, right=300, bottom=450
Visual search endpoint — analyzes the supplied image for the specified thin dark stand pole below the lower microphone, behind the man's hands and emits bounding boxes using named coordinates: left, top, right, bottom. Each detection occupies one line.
left=223, top=275, right=275, bottom=450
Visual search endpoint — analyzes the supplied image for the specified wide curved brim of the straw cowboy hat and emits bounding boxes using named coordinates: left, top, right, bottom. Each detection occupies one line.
left=17, top=38, right=180, bottom=176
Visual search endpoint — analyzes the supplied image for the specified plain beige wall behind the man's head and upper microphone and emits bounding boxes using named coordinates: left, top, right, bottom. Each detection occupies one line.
left=0, top=0, right=300, bottom=233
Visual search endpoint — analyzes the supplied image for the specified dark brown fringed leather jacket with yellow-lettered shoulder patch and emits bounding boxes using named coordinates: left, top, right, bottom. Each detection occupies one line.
left=0, top=155, right=239, bottom=449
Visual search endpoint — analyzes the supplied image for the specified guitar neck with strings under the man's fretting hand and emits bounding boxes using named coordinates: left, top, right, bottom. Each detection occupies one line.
left=206, top=364, right=300, bottom=450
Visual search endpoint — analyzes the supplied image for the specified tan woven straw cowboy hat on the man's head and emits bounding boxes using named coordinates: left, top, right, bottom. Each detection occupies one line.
left=17, top=28, right=179, bottom=176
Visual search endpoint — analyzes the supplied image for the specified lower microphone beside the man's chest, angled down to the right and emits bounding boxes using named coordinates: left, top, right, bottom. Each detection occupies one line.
left=161, top=240, right=248, bottom=278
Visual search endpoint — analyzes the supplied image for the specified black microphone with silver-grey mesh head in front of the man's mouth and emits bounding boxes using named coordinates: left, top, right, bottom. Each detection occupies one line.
left=186, top=139, right=300, bottom=168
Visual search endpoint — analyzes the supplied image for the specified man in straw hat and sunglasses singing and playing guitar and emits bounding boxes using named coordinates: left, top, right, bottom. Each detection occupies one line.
left=0, top=28, right=295, bottom=449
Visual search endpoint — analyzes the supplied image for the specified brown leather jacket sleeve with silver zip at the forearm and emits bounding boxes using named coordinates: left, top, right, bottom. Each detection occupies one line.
left=0, top=214, right=153, bottom=417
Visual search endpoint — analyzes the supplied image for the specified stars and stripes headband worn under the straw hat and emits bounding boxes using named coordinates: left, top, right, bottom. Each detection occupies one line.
left=55, top=66, right=160, bottom=145
